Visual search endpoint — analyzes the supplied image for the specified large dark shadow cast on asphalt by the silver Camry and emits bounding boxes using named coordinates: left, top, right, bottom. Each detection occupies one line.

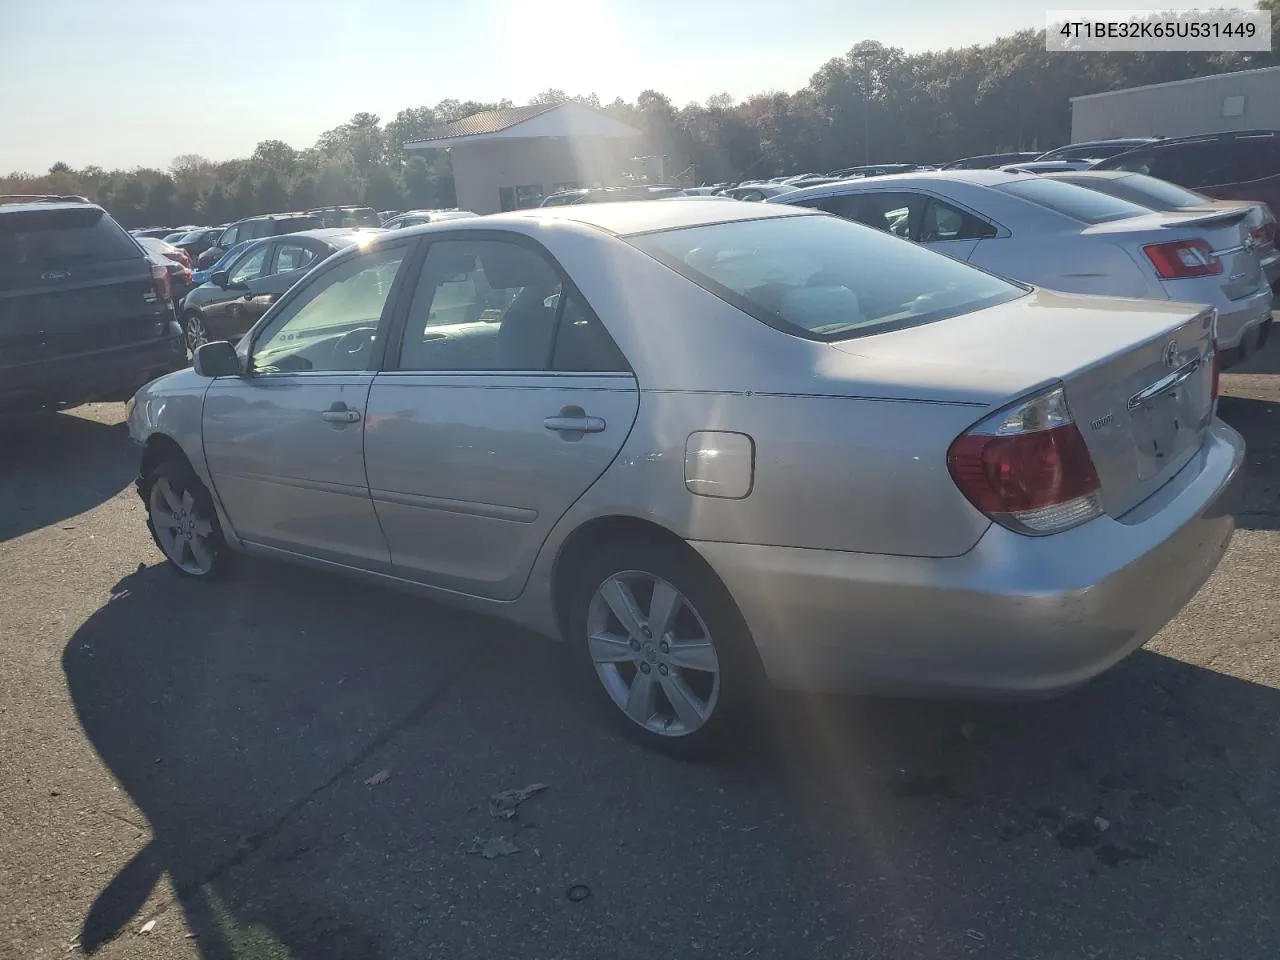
left=63, top=561, right=1280, bottom=960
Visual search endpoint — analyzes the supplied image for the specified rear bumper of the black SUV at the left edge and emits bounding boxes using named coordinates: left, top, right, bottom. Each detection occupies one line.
left=0, top=320, right=187, bottom=407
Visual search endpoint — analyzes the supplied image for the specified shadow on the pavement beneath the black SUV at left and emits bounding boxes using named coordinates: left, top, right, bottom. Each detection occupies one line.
left=0, top=413, right=138, bottom=543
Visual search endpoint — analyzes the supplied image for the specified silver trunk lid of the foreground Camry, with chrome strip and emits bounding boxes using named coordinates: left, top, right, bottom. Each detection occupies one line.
left=833, top=291, right=1213, bottom=516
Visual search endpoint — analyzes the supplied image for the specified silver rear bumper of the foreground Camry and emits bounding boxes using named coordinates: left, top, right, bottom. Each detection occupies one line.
left=692, top=421, right=1244, bottom=698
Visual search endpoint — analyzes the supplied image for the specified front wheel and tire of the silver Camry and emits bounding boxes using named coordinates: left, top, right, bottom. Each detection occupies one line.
left=142, top=460, right=229, bottom=579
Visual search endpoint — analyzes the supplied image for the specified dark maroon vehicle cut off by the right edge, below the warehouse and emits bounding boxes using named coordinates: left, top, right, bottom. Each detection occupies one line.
left=1093, top=131, right=1280, bottom=227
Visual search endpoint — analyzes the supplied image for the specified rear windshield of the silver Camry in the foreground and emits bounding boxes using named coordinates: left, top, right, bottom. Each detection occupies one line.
left=628, top=215, right=1025, bottom=340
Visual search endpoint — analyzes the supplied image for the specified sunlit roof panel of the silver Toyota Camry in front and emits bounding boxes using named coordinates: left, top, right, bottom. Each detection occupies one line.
left=394, top=195, right=814, bottom=237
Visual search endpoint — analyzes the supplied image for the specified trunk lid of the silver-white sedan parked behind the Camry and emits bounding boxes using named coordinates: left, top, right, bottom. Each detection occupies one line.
left=1084, top=207, right=1262, bottom=300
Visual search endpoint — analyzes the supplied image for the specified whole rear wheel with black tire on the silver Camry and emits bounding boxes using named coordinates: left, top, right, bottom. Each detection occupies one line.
left=568, top=541, right=763, bottom=759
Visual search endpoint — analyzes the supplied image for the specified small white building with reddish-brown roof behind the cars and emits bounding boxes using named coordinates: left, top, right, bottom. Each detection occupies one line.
left=404, top=101, right=640, bottom=214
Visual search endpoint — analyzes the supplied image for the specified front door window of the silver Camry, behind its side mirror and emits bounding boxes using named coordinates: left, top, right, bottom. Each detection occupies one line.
left=251, top=244, right=408, bottom=374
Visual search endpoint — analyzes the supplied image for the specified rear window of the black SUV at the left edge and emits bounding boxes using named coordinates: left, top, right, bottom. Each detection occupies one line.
left=0, top=207, right=142, bottom=280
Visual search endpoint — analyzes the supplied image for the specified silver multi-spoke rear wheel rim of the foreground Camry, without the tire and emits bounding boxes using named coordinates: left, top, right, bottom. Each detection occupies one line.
left=586, top=570, right=721, bottom=737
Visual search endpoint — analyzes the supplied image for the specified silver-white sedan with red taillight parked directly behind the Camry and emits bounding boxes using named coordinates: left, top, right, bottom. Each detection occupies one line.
left=771, top=170, right=1271, bottom=365
